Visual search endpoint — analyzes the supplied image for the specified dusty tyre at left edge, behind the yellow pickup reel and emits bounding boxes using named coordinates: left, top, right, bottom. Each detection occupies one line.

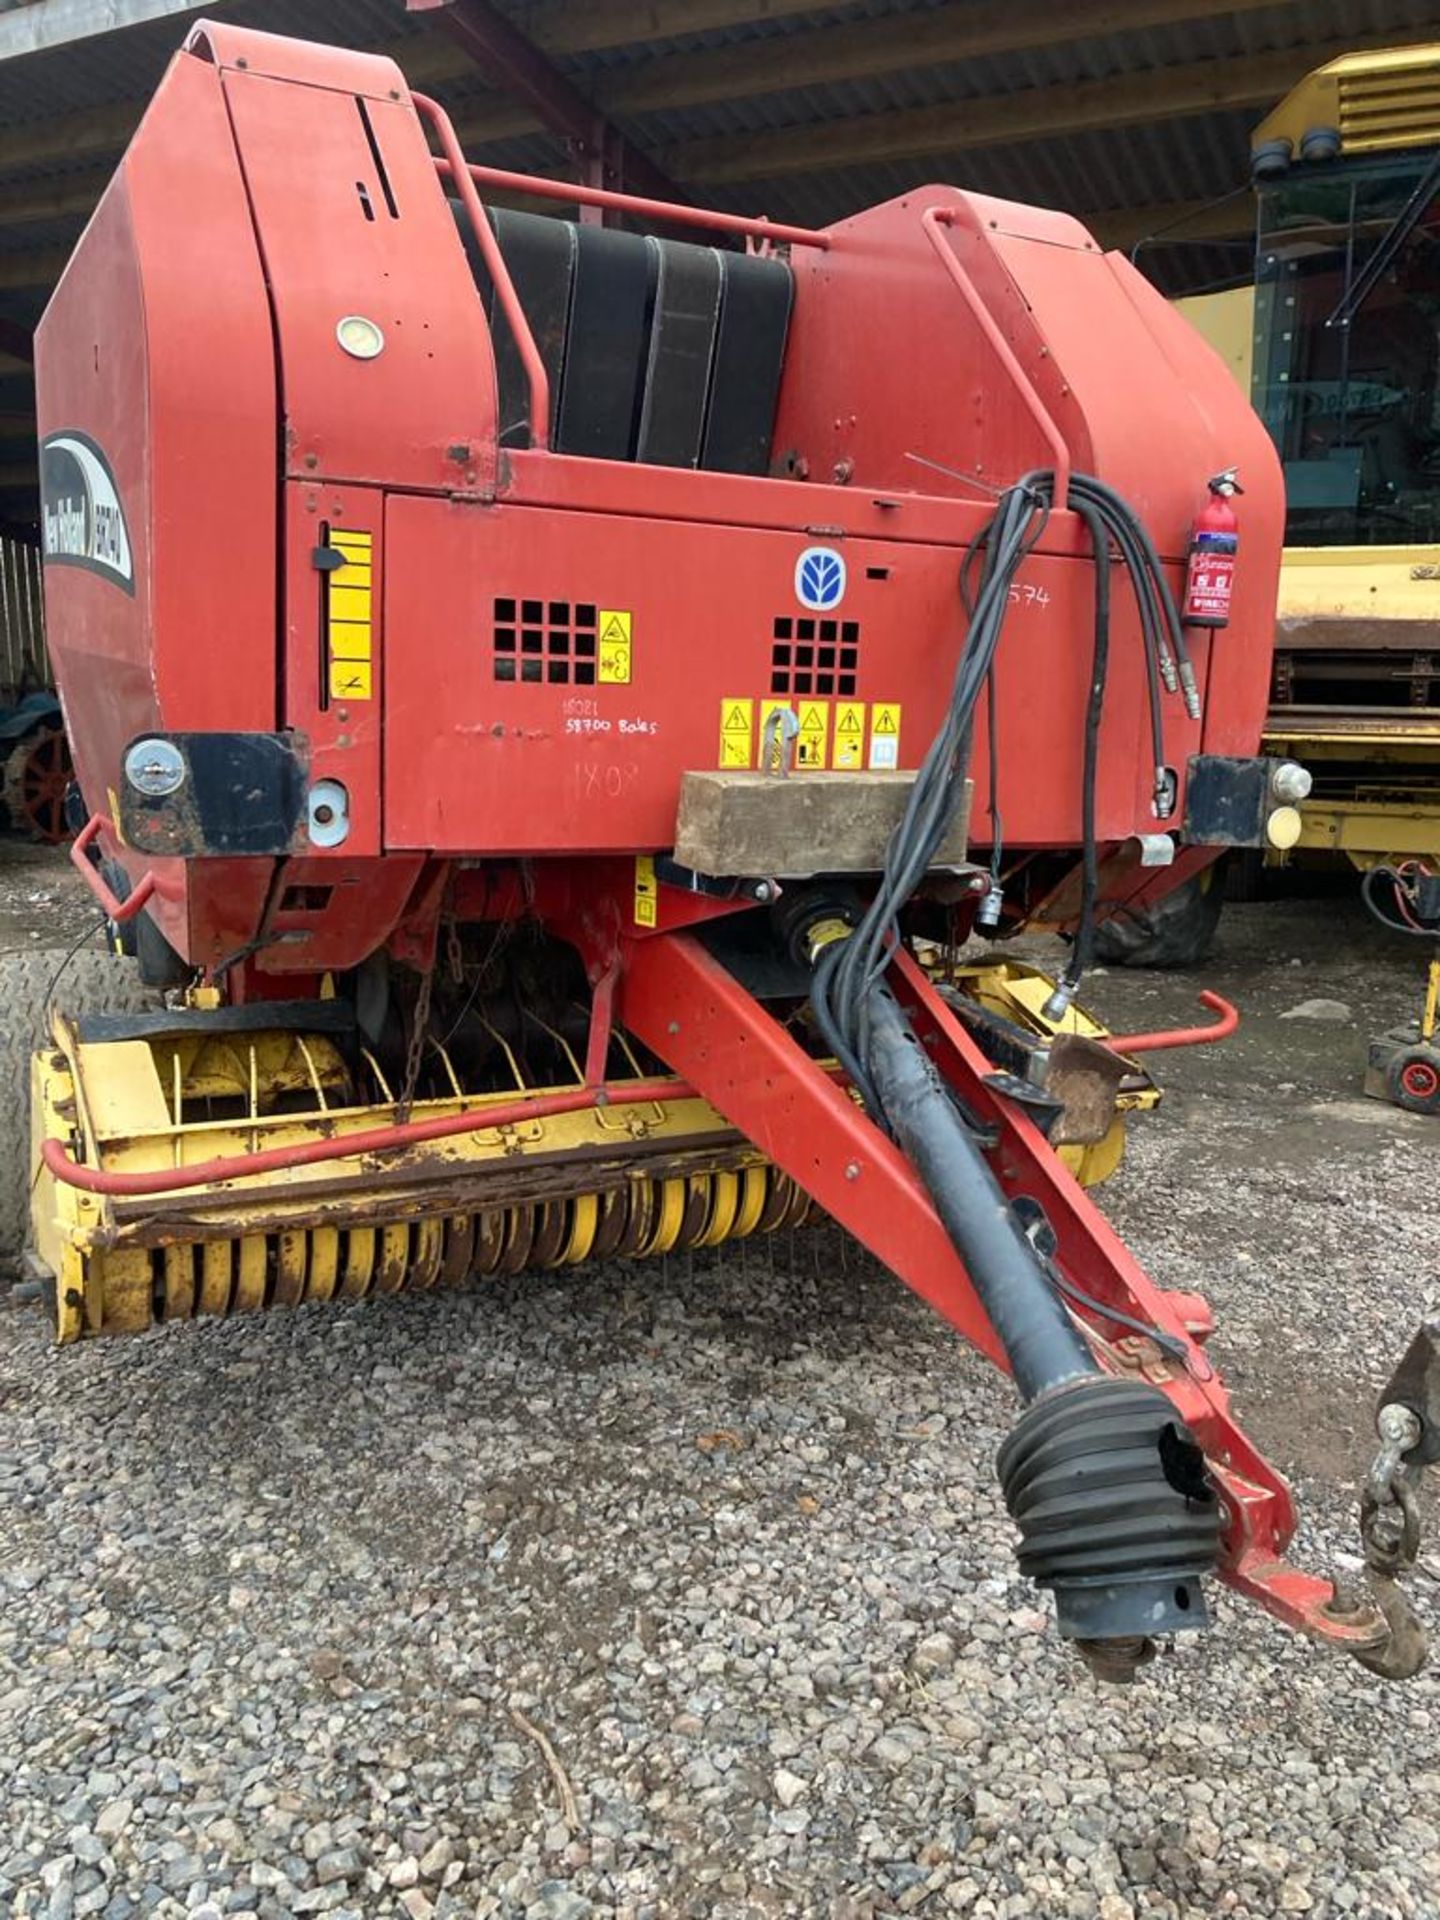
left=0, top=950, right=156, bottom=1261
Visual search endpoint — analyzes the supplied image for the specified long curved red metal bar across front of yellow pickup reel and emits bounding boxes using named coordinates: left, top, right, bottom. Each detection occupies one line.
left=40, top=1079, right=697, bottom=1194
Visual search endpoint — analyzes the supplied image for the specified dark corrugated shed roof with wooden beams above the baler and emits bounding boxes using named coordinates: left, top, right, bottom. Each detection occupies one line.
left=0, top=0, right=1440, bottom=518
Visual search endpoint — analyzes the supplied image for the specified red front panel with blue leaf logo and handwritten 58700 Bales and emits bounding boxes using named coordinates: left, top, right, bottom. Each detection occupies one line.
left=374, top=495, right=1198, bottom=854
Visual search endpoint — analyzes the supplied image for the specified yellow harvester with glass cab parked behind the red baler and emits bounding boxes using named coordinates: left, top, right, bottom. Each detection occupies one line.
left=1179, top=46, right=1440, bottom=868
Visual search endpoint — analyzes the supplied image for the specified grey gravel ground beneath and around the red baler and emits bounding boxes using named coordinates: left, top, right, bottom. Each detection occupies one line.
left=0, top=870, right=1440, bottom=1920
